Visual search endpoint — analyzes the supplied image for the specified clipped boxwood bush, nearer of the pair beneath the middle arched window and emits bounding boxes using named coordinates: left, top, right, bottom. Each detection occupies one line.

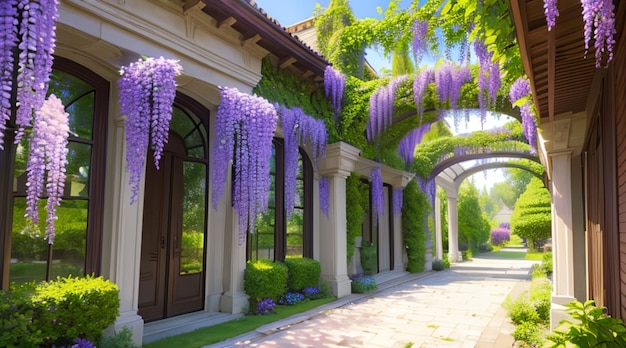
left=243, top=259, right=288, bottom=313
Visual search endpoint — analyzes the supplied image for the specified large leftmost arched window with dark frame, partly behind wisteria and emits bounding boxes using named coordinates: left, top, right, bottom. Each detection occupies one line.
left=0, top=57, right=109, bottom=282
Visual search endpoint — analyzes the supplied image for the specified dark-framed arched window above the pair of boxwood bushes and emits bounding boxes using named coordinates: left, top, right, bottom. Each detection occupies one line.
left=247, top=139, right=313, bottom=261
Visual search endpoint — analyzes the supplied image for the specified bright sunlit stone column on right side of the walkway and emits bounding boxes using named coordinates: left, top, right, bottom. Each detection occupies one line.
left=548, top=151, right=575, bottom=327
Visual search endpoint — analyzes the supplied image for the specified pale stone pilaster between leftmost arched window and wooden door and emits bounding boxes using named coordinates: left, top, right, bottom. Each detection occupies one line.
left=102, top=118, right=144, bottom=345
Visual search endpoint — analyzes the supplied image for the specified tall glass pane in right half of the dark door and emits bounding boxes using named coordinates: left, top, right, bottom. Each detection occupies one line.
left=180, top=162, right=206, bottom=274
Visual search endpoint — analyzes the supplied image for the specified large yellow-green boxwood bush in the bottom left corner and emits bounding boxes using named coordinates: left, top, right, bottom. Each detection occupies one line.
left=0, top=276, right=120, bottom=347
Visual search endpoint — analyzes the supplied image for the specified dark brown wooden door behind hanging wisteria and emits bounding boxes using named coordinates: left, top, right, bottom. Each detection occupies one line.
left=139, top=136, right=204, bottom=321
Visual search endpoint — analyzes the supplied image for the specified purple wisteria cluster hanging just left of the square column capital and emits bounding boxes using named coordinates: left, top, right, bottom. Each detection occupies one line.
left=275, top=105, right=328, bottom=220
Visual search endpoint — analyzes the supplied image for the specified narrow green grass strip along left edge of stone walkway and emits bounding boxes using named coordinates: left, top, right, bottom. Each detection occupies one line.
left=144, top=298, right=335, bottom=348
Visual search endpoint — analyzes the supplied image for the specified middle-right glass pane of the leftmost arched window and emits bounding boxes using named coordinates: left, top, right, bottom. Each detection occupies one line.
left=65, top=141, right=91, bottom=198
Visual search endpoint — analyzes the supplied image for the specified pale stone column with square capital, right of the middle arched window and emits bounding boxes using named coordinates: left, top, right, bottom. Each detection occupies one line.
left=320, top=142, right=359, bottom=298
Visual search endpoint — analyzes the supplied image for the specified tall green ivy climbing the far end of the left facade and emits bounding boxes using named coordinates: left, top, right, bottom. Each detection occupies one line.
left=402, top=180, right=430, bottom=273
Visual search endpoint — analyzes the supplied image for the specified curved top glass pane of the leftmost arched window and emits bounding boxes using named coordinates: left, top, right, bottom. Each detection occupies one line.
left=48, top=70, right=94, bottom=139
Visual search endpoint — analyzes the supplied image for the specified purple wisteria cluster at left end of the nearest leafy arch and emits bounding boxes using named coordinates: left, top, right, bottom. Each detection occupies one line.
left=366, top=75, right=407, bottom=142
